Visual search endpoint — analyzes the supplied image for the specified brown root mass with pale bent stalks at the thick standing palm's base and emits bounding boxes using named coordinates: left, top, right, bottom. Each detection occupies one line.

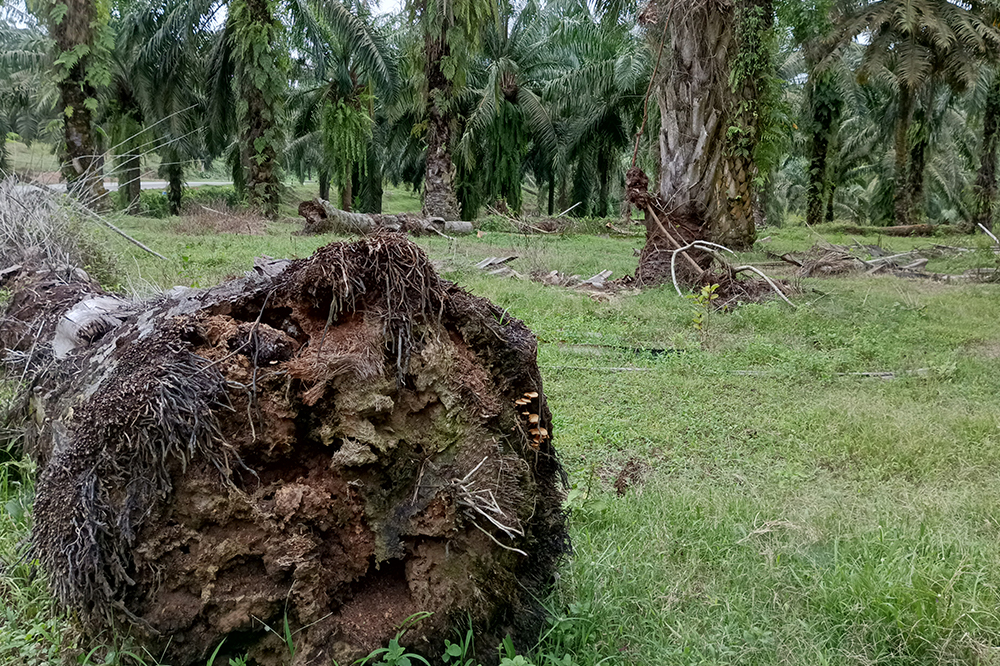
left=625, top=167, right=792, bottom=307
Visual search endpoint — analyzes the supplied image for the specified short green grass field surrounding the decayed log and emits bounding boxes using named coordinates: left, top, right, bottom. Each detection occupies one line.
left=0, top=200, right=1000, bottom=666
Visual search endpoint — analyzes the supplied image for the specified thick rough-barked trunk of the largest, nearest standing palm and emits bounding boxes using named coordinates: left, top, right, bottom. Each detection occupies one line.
left=647, top=0, right=772, bottom=254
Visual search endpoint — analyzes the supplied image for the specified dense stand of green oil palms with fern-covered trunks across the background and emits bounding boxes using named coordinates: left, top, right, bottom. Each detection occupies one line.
left=0, top=0, right=1000, bottom=239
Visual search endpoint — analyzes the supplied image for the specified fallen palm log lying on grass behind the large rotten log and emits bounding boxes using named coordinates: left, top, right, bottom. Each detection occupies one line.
left=299, top=199, right=475, bottom=236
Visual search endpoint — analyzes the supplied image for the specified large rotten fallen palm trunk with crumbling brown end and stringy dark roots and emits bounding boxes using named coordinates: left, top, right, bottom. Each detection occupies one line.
left=0, top=234, right=568, bottom=665
